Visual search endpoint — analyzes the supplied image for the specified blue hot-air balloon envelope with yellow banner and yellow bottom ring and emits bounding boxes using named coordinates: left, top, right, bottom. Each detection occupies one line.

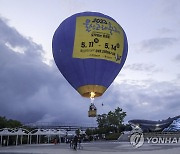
left=52, top=12, right=128, bottom=97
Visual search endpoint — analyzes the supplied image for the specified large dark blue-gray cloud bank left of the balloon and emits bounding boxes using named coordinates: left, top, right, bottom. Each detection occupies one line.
left=0, top=16, right=89, bottom=122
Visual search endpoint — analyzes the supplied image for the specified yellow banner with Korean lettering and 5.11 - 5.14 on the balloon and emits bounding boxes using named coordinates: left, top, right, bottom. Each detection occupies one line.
left=73, top=16, right=124, bottom=64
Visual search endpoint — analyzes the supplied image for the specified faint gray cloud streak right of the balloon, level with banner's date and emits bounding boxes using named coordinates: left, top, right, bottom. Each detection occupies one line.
left=141, top=37, right=178, bottom=52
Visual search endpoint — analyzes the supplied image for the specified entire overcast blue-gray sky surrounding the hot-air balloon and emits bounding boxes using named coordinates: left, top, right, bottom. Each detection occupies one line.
left=0, top=0, right=180, bottom=123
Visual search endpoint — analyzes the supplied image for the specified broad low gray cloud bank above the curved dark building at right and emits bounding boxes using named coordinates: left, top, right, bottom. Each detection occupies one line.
left=103, top=82, right=180, bottom=120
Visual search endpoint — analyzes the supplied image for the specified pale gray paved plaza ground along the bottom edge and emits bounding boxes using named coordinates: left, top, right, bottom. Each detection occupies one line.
left=0, top=142, right=180, bottom=154
